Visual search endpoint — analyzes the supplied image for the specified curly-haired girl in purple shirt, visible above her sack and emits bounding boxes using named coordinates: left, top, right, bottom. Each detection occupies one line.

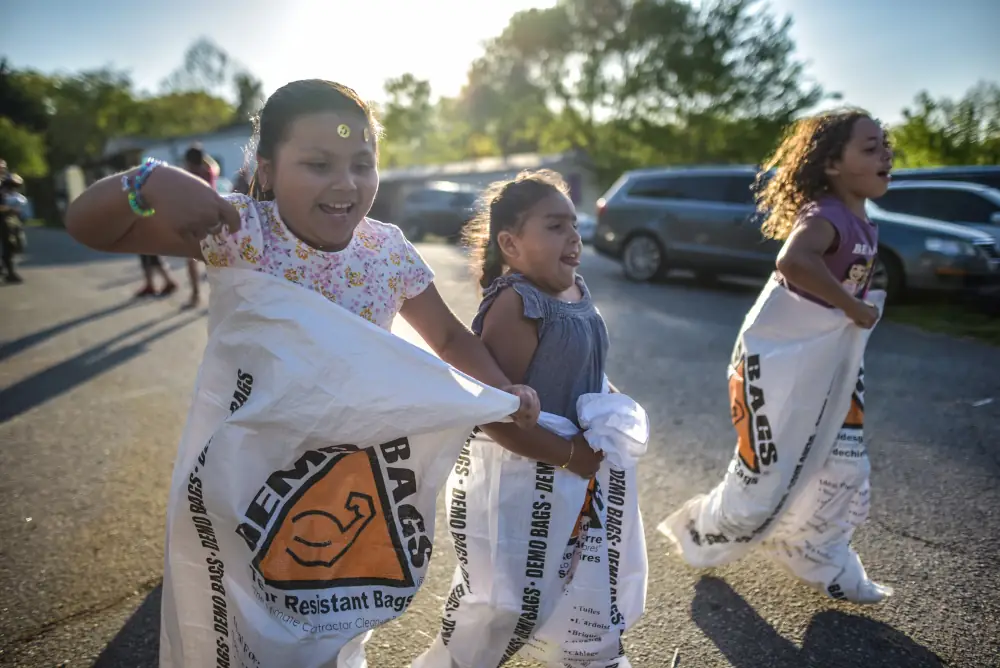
left=758, top=110, right=892, bottom=320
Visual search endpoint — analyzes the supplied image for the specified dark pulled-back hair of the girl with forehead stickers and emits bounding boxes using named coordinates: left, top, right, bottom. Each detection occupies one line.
left=244, top=79, right=382, bottom=201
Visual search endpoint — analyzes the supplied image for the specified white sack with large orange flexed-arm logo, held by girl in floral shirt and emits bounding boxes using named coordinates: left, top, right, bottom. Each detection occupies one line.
left=160, top=269, right=518, bottom=668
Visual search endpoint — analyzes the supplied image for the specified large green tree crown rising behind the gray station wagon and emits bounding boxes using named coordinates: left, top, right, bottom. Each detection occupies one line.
left=450, top=0, right=823, bottom=178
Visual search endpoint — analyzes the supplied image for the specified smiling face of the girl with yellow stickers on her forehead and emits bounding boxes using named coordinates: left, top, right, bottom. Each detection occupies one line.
left=258, top=112, right=378, bottom=251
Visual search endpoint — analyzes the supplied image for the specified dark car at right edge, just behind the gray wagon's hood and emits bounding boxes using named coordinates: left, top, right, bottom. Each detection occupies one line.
left=875, top=181, right=1000, bottom=243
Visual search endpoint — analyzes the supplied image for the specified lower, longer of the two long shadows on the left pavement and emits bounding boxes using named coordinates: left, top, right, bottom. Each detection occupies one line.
left=0, top=311, right=205, bottom=422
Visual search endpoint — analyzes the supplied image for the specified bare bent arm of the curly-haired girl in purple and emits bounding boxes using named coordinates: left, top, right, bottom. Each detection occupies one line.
left=777, top=218, right=858, bottom=315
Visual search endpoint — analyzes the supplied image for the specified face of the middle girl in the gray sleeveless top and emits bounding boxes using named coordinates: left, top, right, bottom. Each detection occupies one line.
left=497, top=189, right=583, bottom=294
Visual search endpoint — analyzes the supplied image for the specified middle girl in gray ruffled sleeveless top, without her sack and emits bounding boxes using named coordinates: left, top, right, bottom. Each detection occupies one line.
left=466, top=170, right=608, bottom=478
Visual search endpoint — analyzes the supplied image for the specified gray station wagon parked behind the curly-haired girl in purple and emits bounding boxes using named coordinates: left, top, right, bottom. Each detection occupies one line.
left=594, top=166, right=1000, bottom=297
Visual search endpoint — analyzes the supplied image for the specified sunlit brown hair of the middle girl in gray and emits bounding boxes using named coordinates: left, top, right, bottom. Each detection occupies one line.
left=462, top=169, right=569, bottom=289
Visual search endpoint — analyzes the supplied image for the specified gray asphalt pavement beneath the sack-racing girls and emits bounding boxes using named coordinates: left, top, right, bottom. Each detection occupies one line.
left=0, top=229, right=1000, bottom=668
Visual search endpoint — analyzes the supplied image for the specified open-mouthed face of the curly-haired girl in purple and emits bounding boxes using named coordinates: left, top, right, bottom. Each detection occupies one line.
left=826, top=116, right=892, bottom=199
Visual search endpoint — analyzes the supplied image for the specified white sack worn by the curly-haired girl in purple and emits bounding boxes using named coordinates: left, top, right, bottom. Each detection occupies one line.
left=658, top=281, right=889, bottom=602
